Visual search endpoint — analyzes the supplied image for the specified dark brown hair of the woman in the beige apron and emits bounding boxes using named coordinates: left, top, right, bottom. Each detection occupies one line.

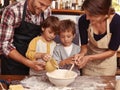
left=82, top=0, right=115, bottom=15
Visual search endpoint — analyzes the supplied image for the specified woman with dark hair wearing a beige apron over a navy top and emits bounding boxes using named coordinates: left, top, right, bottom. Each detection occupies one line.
left=74, top=0, right=120, bottom=76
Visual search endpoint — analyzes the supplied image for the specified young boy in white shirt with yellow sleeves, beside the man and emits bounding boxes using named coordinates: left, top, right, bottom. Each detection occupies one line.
left=26, top=16, right=59, bottom=75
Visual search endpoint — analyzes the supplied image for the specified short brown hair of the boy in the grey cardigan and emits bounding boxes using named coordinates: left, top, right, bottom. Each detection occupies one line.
left=59, top=19, right=76, bottom=34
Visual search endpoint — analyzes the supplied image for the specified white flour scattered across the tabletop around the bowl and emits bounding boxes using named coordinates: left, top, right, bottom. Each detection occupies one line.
left=21, top=76, right=114, bottom=90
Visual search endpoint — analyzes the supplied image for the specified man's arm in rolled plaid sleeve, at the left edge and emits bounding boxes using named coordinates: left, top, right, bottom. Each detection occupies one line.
left=0, top=4, right=45, bottom=70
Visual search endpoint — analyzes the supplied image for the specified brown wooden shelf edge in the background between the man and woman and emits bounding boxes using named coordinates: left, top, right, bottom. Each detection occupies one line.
left=52, top=9, right=84, bottom=15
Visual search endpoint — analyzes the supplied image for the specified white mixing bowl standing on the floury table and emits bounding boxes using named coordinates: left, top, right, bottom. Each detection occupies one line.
left=46, top=69, right=77, bottom=87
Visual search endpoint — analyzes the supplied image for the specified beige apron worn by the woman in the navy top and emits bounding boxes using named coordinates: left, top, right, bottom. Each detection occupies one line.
left=83, top=20, right=117, bottom=76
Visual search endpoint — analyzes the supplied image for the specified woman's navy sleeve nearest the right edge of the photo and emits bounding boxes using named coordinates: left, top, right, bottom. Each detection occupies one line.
left=108, top=14, right=120, bottom=51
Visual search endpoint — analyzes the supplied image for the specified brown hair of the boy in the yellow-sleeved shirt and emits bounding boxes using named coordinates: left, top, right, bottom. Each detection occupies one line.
left=41, top=16, right=59, bottom=34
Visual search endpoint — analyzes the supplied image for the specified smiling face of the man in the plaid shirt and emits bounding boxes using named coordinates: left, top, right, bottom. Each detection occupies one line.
left=28, top=0, right=52, bottom=15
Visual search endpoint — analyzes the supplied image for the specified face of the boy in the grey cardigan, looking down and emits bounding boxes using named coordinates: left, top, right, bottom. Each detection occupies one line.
left=60, top=30, right=75, bottom=46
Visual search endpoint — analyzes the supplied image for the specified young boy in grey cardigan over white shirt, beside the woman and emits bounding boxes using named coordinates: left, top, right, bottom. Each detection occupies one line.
left=53, top=19, right=80, bottom=74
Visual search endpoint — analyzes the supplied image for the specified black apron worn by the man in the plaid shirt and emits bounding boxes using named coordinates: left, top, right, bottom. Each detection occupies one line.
left=1, top=0, right=41, bottom=75
